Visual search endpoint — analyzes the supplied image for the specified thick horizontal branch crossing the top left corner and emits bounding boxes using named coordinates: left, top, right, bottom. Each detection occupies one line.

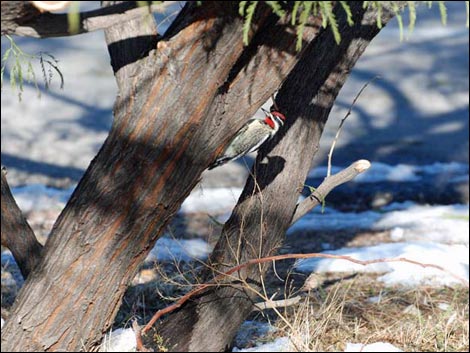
left=1, top=1, right=173, bottom=38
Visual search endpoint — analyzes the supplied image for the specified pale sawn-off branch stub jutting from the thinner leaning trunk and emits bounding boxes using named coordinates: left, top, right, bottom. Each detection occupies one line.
left=291, top=159, right=370, bottom=225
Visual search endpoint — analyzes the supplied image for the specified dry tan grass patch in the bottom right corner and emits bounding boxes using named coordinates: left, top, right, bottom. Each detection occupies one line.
left=270, top=274, right=469, bottom=352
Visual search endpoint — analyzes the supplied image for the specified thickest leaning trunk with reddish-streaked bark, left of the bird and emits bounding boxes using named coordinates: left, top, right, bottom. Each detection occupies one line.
left=2, top=2, right=319, bottom=351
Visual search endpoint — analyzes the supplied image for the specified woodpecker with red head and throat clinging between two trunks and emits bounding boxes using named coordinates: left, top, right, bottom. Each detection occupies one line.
left=208, top=108, right=286, bottom=169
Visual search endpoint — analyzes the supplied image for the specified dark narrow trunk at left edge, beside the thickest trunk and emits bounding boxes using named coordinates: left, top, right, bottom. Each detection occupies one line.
left=1, top=169, right=42, bottom=279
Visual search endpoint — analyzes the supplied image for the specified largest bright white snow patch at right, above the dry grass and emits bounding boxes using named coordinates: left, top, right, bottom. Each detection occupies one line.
left=288, top=202, right=469, bottom=286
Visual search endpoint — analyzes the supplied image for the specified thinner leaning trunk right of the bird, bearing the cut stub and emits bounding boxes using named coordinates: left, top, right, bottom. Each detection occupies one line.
left=154, top=2, right=393, bottom=352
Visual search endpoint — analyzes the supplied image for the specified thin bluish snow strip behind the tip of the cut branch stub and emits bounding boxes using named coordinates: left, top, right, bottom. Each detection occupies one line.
left=308, top=162, right=468, bottom=183
